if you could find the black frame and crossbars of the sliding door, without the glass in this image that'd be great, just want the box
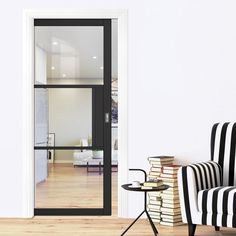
[34,19,112,215]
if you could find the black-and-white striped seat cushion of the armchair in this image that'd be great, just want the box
[198,186,236,215]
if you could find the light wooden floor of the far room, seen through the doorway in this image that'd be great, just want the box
[35,164,117,208]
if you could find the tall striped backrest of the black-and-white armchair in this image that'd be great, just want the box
[211,122,236,186]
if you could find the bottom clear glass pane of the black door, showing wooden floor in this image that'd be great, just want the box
[35,150,103,208]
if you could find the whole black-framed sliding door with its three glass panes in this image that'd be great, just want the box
[34,19,111,215]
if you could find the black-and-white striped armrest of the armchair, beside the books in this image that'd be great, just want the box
[178,161,222,224]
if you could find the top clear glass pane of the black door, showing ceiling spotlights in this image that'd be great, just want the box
[35,26,104,84]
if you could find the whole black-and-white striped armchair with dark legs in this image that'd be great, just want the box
[178,123,236,236]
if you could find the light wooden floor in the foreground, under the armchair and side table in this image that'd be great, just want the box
[0,217,236,236]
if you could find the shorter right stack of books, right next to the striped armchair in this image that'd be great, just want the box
[159,165,183,226]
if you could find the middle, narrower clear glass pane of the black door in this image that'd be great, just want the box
[35,88,92,146]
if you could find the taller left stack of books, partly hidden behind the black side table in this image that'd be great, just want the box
[147,156,174,223]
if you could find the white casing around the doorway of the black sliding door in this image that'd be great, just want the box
[22,9,128,218]
